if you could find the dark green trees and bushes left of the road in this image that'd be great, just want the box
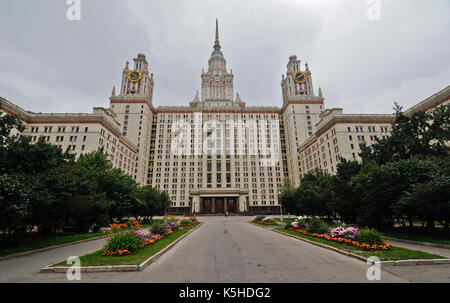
[0,104,170,246]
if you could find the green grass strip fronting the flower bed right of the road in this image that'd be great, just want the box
[276,227,445,261]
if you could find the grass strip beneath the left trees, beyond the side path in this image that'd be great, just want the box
[0,232,104,257]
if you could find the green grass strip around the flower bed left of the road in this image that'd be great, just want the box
[53,229,189,266]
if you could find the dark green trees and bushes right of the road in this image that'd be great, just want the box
[279,104,450,232]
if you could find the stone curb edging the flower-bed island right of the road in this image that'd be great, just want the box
[264,224,450,266]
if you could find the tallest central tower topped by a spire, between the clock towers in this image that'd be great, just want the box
[201,19,233,106]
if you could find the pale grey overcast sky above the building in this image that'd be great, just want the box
[0,0,450,113]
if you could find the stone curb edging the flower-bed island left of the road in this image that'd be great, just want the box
[39,222,205,273]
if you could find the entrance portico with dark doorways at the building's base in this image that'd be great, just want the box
[190,188,248,214]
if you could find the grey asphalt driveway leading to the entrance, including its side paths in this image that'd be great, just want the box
[0,217,450,283]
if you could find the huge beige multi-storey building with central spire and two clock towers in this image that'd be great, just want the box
[0,20,450,214]
